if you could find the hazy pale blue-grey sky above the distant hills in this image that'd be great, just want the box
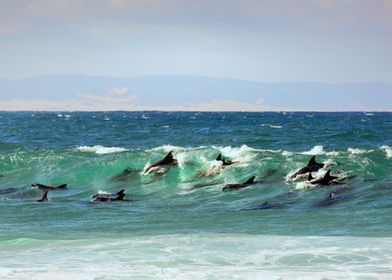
[0,0,392,83]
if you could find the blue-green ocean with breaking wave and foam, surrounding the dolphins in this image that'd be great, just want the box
[0,112,392,279]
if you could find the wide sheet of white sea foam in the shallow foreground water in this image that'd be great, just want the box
[0,234,392,280]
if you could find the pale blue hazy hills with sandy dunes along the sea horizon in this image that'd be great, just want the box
[0,75,392,111]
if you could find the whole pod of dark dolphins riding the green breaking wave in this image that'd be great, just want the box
[0,151,352,210]
